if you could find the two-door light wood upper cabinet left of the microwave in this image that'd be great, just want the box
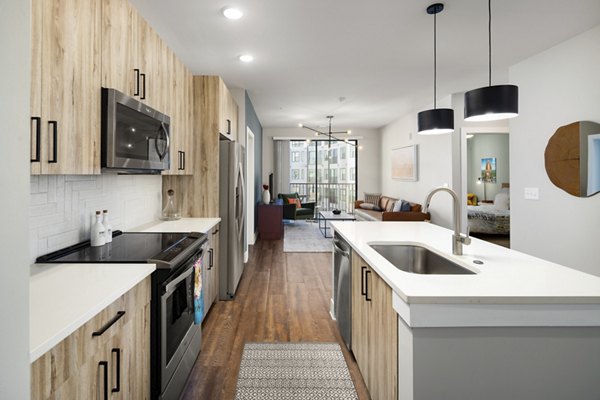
[31,0,101,174]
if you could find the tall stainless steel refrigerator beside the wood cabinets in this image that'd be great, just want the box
[219,140,246,300]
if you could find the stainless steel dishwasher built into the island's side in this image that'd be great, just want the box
[333,232,352,349]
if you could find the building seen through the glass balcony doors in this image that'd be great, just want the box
[290,140,357,212]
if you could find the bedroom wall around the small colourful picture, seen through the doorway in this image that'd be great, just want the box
[467,133,510,200]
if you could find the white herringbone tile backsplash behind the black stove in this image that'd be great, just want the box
[29,174,162,263]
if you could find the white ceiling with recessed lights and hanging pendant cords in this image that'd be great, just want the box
[132,0,600,130]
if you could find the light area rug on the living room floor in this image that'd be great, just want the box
[283,221,331,253]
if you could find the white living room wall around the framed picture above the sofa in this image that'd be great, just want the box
[380,98,452,228]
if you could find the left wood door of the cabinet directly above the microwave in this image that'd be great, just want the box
[102,0,137,98]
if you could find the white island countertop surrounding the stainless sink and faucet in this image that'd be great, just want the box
[332,222,600,306]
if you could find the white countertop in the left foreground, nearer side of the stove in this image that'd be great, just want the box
[29,264,156,362]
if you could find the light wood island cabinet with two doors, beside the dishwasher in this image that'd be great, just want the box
[352,253,398,400]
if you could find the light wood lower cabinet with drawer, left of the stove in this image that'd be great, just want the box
[31,277,151,400]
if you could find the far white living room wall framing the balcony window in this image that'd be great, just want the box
[262,127,381,199]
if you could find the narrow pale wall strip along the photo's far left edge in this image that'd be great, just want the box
[0,0,31,399]
